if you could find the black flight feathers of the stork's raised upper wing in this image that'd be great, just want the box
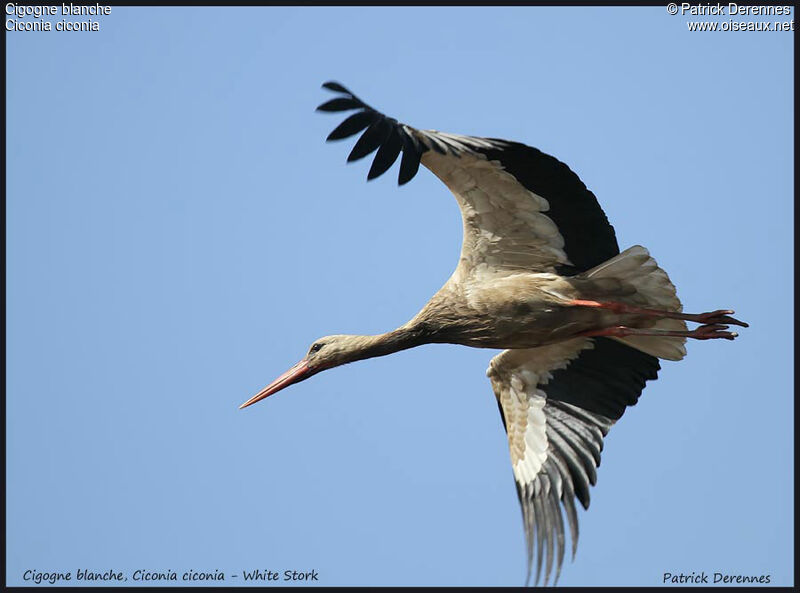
[317,82,619,273]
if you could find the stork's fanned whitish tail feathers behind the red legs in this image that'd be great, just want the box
[584,245,687,360]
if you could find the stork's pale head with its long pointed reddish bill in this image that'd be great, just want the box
[239,335,374,409]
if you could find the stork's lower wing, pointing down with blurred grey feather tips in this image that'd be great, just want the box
[486,338,659,584]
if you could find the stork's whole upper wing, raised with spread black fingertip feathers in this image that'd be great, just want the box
[317,82,619,274]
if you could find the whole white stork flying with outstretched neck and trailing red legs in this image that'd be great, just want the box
[241,82,747,584]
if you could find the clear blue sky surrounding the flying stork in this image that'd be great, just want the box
[6,7,794,585]
